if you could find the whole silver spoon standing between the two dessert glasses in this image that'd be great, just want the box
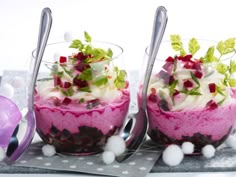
[116,6,167,162]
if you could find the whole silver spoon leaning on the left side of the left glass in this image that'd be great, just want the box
[5,8,52,164]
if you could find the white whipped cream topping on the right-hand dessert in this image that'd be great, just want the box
[148,60,232,111]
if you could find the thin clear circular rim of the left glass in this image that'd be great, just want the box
[31,40,124,66]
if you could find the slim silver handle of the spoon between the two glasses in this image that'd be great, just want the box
[142,6,168,110]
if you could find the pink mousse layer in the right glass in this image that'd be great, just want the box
[147,100,236,140]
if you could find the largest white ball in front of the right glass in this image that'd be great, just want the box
[162,144,184,166]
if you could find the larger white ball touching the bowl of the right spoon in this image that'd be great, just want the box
[105,135,126,156]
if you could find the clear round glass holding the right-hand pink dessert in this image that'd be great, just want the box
[138,40,236,152]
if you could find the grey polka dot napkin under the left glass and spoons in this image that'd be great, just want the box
[10,142,161,177]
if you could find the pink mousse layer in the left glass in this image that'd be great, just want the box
[34,90,130,135]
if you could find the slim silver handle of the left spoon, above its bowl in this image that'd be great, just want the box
[28,8,52,110]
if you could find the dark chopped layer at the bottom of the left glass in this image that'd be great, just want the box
[37,126,118,155]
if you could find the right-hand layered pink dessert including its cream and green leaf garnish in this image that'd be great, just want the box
[138,35,236,152]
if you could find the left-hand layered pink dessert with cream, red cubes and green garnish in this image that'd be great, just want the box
[34,32,130,155]
